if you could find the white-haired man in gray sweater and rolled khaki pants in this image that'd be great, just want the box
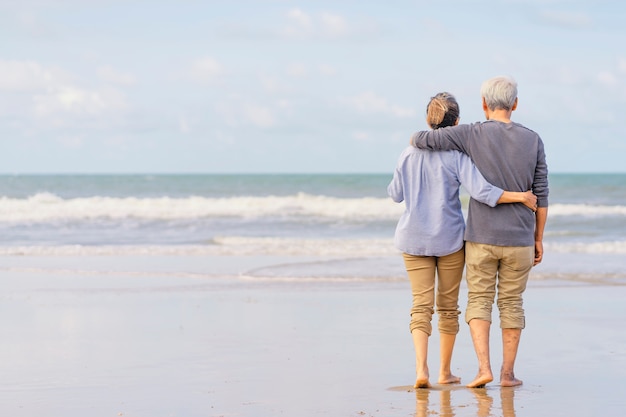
[411,77,548,387]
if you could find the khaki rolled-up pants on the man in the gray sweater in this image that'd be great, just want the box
[465,242,535,329]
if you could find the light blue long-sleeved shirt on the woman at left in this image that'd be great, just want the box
[387,146,503,256]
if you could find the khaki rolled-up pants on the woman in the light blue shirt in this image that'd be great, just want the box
[403,249,465,335]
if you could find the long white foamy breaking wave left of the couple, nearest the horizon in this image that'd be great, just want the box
[0,193,403,222]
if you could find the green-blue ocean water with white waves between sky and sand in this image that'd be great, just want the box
[0,174,626,283]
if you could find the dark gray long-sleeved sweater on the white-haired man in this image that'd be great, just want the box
[411,121,548,246]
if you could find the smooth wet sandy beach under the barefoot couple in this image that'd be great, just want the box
[0,252,626,417]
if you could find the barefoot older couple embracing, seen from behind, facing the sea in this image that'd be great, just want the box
[387,77,548,388]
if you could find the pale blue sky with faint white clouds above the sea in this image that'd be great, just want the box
[0,0,626,174]
